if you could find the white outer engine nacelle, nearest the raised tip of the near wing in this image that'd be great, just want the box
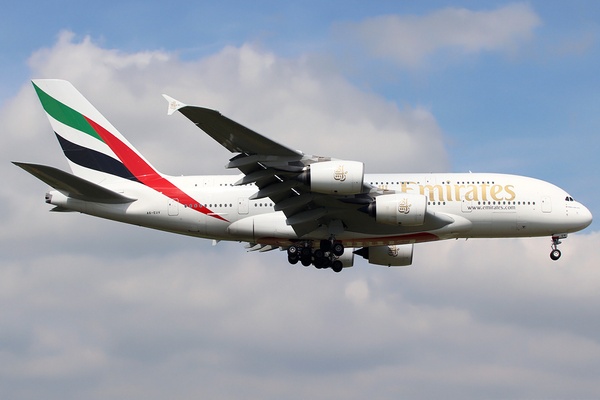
[308,160,365,195]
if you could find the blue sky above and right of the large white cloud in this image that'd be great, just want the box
[0,1,600,209]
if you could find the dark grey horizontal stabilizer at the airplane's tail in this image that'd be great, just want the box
[13,162,136,204]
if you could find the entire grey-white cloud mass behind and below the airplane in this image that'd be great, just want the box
[0,29,600,399]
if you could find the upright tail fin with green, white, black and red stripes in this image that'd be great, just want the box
[32,79,160,182]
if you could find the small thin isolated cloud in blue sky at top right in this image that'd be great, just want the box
[341,3,540,68]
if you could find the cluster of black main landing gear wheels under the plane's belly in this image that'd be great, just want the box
[287,239,344,272]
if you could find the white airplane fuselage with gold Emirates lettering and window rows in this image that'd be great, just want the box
[48,173,592,247]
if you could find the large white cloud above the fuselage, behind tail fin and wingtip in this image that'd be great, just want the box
[16,32,448,174]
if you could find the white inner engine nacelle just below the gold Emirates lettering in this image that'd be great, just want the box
[369,193,427,226]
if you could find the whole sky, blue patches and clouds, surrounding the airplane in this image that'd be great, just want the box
[0,1,600,399]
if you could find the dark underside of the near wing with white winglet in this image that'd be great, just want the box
[163,95,448,237]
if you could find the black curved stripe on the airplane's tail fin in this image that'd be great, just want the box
[54,132,139,182]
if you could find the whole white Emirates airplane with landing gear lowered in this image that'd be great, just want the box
[13,79,592,272]
